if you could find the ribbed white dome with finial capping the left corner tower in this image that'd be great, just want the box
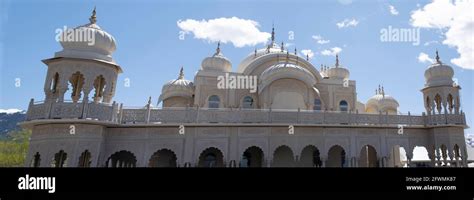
[55,9,116,62]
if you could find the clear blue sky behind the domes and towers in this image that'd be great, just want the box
[0,0,474,136]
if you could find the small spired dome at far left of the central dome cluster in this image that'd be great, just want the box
[159,68,194,102]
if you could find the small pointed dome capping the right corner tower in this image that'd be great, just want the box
[425,51,454,87]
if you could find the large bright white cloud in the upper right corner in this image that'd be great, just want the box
[410,0,474,69]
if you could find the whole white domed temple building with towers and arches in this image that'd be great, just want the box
[22,10,468,167]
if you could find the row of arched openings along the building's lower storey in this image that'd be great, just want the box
[30,144,463,168]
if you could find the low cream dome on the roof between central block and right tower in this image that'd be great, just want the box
[365,88,399,114]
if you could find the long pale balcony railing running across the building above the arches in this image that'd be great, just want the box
[27,100,466,126]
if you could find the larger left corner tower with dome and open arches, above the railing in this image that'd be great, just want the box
[43,8,122,103]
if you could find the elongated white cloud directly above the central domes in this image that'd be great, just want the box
[177,17,271,47]
